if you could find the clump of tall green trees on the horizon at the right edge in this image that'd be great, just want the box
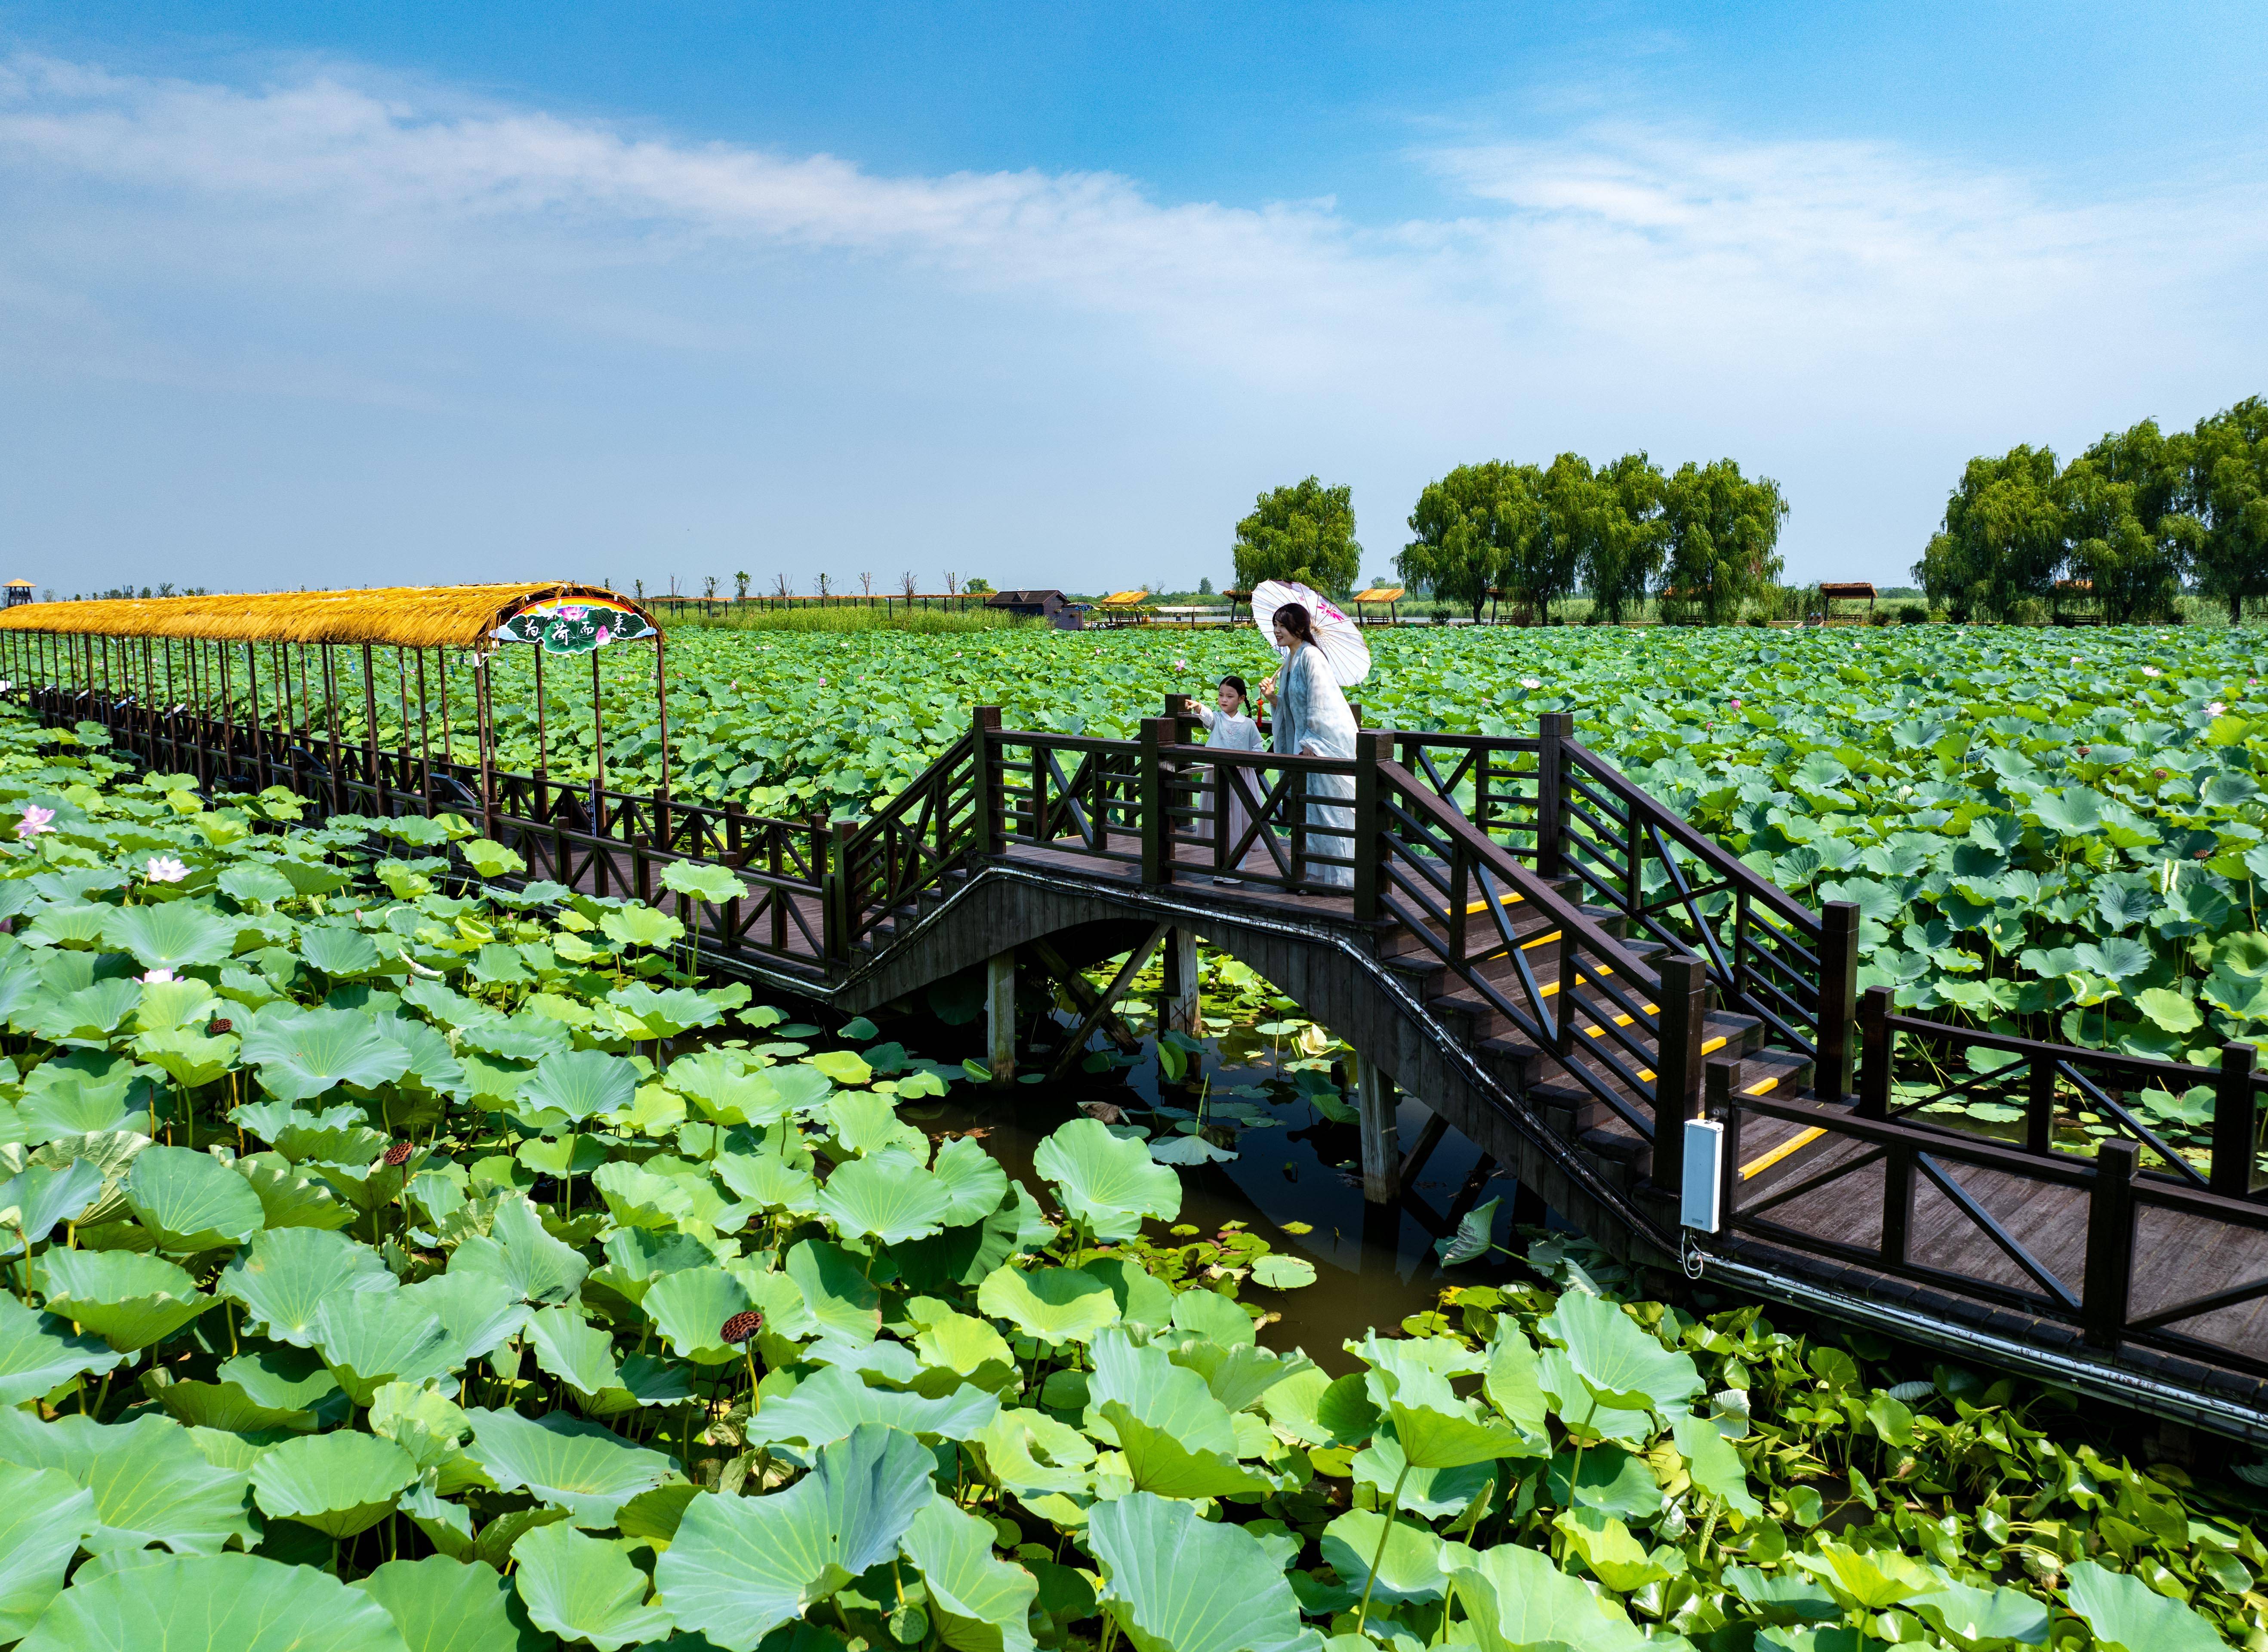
[1914,397,2268,624]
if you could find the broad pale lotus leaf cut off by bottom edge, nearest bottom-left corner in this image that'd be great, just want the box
[23,1554,408,1652]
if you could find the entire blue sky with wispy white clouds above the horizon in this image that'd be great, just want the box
[0,0,2268,590]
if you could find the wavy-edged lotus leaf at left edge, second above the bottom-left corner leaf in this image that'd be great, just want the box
[0,1412,254,1554]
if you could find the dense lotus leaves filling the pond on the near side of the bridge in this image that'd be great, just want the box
[0,721,2268,1652]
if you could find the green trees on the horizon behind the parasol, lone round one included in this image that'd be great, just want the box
[1234,454,1787,624]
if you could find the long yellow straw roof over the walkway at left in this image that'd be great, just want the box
[0,583,651,649]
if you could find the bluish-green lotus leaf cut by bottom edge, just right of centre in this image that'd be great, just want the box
[1086,1489,1322,1652]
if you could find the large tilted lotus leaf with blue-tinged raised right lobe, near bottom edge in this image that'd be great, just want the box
[653,1423,937,1652]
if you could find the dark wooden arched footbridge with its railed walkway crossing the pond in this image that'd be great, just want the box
[14,599,2268,1441]
